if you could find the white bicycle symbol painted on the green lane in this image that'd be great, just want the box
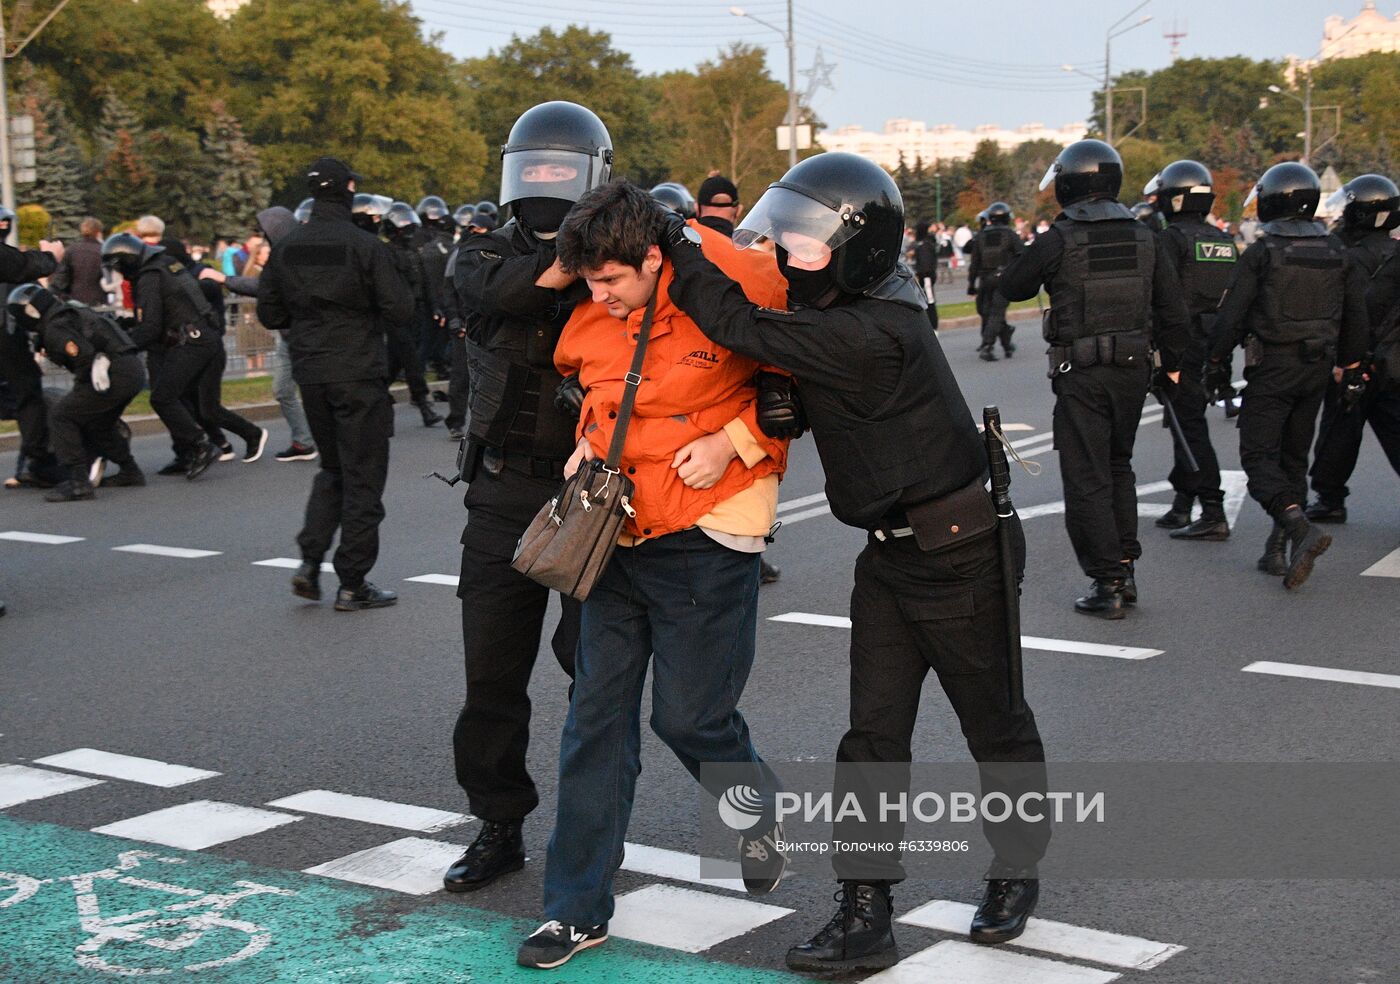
[0,850,297,977]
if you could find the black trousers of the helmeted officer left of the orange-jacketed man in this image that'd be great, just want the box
[452,459,581,822]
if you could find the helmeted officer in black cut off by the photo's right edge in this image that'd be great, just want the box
[1305,174,1400,522]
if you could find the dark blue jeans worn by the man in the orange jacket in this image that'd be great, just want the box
[545,529,773,925]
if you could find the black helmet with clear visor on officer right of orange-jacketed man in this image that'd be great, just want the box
[734,151,904,294]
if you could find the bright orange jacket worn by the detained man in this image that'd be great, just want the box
[554,223,788,537]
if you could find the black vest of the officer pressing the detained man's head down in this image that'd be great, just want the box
[802,298,987,529]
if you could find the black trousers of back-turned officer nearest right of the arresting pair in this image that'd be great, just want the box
[1051,365,1148,578]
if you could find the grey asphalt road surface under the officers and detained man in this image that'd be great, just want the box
[0,323,1400,984]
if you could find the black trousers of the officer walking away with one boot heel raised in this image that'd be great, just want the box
[1239,354,1331,521]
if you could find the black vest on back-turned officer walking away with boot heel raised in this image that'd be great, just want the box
[1254,220,1347,346]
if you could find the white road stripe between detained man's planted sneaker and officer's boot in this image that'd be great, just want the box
[608,885,794,953]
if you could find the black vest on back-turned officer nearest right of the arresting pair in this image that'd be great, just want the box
[1046,200,1156,344]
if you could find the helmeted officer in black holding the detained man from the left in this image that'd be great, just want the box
[444,102,613,892]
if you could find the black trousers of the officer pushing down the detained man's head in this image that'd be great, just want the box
[833,519,1050,882]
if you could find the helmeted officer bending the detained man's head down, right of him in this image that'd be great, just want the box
[665,153,1049,971]
